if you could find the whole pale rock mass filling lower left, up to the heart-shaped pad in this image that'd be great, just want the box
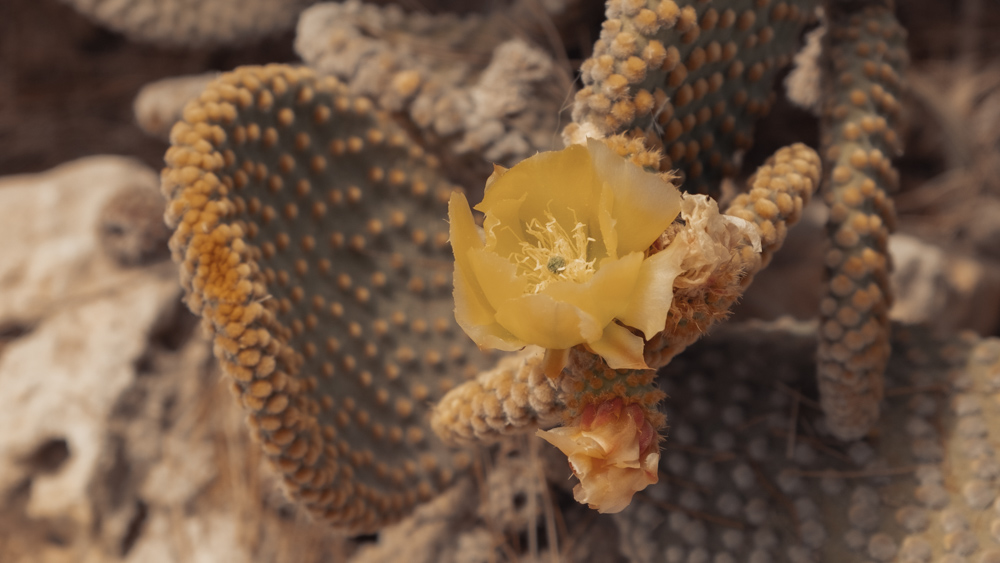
[0,157,345,563]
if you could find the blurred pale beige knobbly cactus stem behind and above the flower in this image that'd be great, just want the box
[295,0,572,177]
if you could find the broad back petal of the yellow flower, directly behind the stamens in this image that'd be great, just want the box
[476,145,601,238]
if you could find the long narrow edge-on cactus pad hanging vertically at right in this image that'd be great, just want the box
[818,3,907,440]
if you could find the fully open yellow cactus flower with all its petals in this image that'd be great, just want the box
[448,140,685,369]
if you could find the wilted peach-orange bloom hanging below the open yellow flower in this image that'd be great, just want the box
[538,398,660,513]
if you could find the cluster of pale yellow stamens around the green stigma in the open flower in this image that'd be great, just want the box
[514,211,596,293]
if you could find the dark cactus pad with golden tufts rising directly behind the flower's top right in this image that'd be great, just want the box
[563,0,817,195]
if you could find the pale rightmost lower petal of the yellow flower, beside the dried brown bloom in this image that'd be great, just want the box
[618,240,686,339]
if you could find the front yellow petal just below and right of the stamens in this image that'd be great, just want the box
[542,252,642,326]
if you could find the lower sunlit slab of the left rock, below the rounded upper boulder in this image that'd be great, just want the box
[0,278,179,523]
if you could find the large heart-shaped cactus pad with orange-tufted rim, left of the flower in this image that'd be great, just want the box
[163,65,492,532]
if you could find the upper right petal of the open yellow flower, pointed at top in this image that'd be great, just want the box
[587,139,681,254]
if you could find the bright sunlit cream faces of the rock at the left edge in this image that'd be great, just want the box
[0,157,180,524]
